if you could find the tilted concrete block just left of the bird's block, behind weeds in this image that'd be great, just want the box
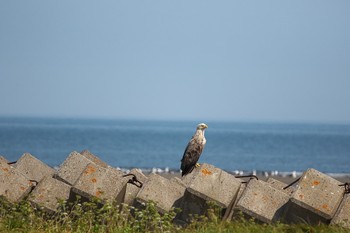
[136,174,186,213]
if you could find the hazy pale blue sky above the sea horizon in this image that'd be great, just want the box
[0,0,350,123]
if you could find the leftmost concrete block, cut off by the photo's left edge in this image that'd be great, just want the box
[0,161,33,202]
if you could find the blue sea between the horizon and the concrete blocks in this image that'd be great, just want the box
[0,117,350,173]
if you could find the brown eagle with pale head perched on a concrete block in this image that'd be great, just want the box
[181,123,208,176]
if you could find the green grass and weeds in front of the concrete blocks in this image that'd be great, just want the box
[0,199,350,233]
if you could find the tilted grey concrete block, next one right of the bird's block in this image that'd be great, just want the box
[237,179,289,223]
